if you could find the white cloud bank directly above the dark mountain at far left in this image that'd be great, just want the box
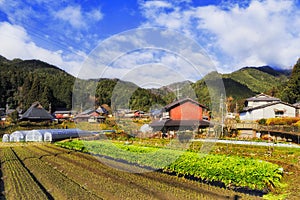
[0,22,86,76]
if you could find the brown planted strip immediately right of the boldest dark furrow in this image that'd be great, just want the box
[14,147,99,199]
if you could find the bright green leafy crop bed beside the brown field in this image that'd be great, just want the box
[58,140,283,191]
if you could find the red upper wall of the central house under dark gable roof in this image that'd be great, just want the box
[169,102,202,120]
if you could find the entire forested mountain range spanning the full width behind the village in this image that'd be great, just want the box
[0,56,300,114]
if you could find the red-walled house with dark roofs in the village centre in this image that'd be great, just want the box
[150,98,210,133]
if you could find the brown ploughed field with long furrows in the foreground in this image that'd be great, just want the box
[0,144,259,199]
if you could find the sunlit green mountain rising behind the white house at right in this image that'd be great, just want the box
[162,66,294,112]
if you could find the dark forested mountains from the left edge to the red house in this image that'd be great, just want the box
[0,56,165,112]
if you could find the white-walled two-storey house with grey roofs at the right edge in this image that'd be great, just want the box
[240,94,298,121]
